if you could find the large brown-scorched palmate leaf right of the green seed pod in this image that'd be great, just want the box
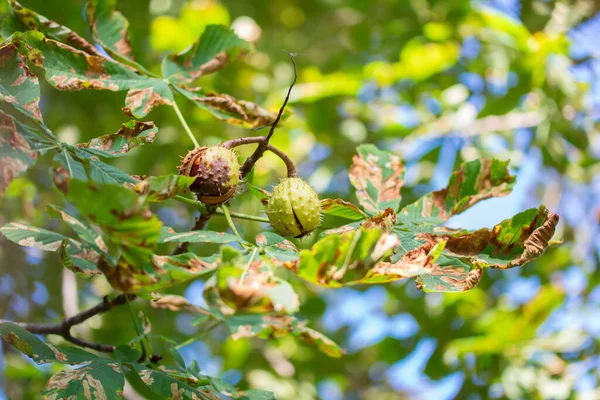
[284,145,558,292]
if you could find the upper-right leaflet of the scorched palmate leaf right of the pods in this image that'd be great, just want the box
[398,159,515,225]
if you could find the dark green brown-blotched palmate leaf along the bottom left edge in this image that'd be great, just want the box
[0,323,273,400]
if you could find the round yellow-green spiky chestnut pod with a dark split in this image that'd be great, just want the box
[267,178,321,238]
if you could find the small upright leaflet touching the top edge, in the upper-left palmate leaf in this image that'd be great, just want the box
[87,0,131,58]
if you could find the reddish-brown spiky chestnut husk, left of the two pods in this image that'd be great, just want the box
[179,146,240,204]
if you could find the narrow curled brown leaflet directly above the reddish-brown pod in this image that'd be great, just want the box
[175,86,275,128]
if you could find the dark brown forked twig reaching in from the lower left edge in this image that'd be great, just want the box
[0,294,135,353]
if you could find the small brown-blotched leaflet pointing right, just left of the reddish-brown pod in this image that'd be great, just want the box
[77,120,158,157]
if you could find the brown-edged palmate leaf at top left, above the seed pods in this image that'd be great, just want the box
[0,7,275,127]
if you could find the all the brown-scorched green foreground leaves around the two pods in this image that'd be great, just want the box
[0,0,558,399]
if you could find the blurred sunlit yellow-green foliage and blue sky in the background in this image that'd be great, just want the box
[0,0,600,400]
